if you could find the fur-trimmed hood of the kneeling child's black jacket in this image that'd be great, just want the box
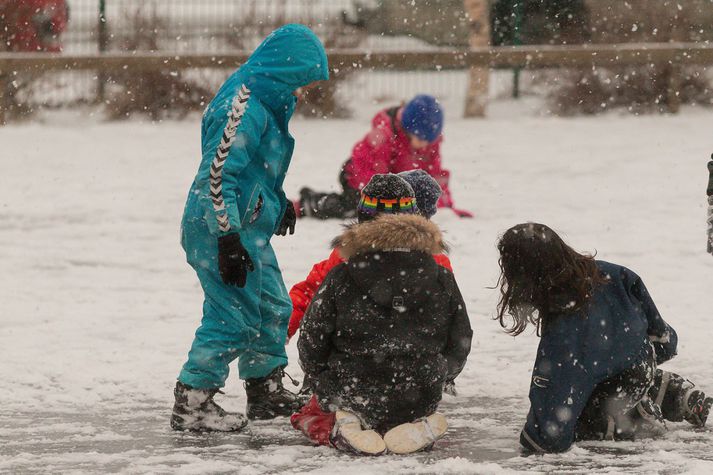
[334,214,446,313]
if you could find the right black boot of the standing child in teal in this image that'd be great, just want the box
[245,367,301,420]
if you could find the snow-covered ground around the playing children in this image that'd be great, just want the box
[0,101,713,474]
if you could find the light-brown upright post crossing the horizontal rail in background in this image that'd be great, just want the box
[463,0,490,117]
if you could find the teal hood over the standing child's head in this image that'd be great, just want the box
[240,24,329,119]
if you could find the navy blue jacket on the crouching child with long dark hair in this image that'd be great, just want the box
[520,261,678,452]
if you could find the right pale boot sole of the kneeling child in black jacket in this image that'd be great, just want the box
[384,412,448,454]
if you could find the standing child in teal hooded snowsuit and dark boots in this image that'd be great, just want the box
[171,25,328,430]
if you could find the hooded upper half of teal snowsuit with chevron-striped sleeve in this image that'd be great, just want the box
[183,24,329,252]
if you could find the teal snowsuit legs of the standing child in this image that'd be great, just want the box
[178,210,292,389]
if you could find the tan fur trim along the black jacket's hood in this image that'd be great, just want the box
[332,214,448,260]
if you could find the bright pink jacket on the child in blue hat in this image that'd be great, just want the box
[344,108,453,208]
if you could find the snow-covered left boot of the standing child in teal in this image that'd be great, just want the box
[171,381,248,432]
